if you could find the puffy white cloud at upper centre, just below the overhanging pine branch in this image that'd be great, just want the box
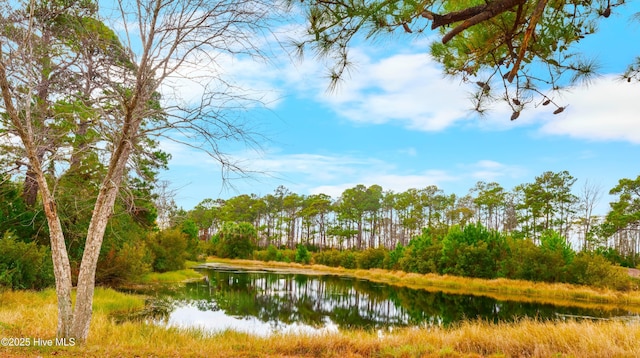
[310,49,476,131]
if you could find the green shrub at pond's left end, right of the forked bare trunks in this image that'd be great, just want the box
[147,229,188,272]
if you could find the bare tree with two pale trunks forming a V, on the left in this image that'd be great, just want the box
[0,0,274,341]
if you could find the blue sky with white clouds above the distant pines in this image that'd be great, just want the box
[161,3,640,214]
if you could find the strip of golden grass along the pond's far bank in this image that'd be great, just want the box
[209,258,640,312]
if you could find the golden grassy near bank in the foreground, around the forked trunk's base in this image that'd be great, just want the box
[0,289,640,357]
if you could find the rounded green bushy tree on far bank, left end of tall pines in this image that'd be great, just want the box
[216,221,257,259]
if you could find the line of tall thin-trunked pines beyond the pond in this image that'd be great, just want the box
[181,171,640,267]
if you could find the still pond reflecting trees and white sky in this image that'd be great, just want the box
[129,267,638,335]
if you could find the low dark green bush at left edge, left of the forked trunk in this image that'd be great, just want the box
[0,232,54,289]
